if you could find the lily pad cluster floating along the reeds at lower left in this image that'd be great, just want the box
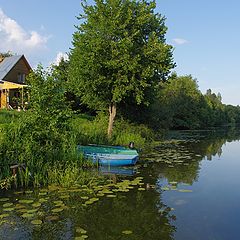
[0,177,145,229]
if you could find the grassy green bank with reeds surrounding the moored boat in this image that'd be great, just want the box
[0,111,153,188]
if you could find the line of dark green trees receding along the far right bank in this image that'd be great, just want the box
[115,73,240,129]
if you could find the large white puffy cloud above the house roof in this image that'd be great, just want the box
[0,8,49,54]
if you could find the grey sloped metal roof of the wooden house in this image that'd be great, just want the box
[0,55,31,80]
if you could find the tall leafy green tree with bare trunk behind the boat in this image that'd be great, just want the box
[69,0,175,137]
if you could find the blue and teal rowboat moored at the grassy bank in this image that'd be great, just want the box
[78,145,139,166]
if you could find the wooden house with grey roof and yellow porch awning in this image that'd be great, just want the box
[0,55,31,109]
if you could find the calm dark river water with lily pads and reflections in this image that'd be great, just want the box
[0,130,240,240]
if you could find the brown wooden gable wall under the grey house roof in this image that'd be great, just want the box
[3,58,30,83]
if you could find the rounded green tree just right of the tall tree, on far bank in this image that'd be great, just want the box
[154,74,206,129]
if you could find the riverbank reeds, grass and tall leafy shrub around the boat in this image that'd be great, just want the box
[0,66,153,188]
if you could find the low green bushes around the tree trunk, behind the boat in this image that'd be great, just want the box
[71,113,154,148]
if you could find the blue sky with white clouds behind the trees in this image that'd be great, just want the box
[0,0,240,105]
